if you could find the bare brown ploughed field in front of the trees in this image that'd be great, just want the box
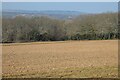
[2,40,118,78]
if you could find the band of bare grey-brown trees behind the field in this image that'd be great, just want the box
[2,13,119,43]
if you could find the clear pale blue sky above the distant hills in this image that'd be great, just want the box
[2,2,118,13]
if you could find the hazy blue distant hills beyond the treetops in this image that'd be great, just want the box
[2,10,85,19]
